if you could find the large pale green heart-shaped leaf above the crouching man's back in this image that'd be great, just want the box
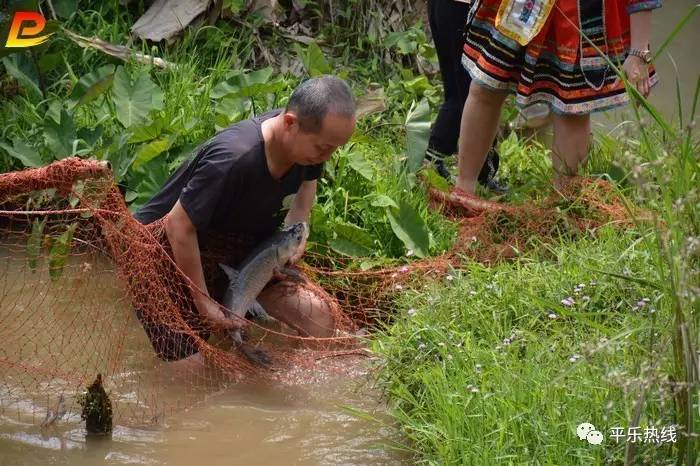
[112,66,163,128]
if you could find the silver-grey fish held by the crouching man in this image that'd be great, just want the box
[219,223,309,366]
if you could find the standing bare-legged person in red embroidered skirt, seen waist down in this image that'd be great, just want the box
[452,0,661,198]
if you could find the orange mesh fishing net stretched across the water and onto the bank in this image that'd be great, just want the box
[0,158,628,424]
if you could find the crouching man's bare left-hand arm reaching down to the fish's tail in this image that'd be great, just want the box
[165,201,243,329]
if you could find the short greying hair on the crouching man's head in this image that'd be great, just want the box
[285,75,355,133]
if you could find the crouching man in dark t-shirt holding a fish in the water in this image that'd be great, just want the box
[135,76,355,368]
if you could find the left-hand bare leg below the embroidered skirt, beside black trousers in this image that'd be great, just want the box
[457,81,508,194]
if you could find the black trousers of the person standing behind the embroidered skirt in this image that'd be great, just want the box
[428,0,498,183]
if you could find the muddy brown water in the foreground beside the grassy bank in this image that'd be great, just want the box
[0,240,406,466]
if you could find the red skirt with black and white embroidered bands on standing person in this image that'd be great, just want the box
[462,0,660,114]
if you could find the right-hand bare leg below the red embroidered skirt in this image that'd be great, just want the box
[552,115,591,189]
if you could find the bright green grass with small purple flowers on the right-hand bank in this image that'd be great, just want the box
[373,228,674,465]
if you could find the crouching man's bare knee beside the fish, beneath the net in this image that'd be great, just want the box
[258,282,336,337]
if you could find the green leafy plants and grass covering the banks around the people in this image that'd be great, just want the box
[0,0,700,465]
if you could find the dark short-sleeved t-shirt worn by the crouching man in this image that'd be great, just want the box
[134,110,322,240]
